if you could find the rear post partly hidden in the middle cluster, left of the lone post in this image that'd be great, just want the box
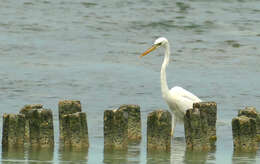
[119,104,142,142]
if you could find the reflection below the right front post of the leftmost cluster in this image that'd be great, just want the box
[28,146,54,163]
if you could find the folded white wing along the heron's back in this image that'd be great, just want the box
[170,86,201,102]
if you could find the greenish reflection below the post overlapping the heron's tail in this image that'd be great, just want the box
[184,150,208,164]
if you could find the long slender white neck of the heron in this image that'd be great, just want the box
[161,44,170,98]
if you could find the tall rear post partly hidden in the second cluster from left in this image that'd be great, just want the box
[59,100,82,142]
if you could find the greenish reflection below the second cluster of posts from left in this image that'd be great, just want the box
[59,146,88,163]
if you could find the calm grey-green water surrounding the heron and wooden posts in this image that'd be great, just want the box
[0,0,260,164]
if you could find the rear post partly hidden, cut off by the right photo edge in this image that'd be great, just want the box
[238,107,260,141]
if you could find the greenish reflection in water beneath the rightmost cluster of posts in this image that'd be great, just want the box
[232,151,257,164]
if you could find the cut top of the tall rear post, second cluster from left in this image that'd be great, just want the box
[59,100,82,118]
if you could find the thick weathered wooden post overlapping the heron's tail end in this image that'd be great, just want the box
[184,102,217,151]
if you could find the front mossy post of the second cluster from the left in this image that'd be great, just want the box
[61,112,89,149]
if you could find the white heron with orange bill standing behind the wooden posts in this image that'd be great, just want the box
[140,37,201,135]
